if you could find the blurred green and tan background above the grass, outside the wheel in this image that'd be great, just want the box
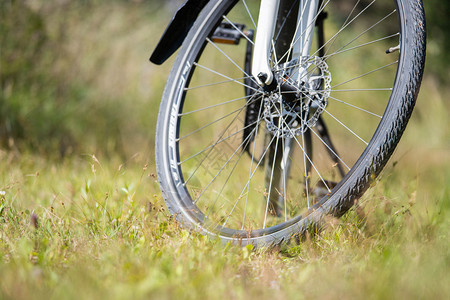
[0,0,450,157]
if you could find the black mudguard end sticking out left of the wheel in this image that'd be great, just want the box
[150,0,209,65]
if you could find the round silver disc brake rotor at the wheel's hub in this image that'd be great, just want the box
[263,56,331,138]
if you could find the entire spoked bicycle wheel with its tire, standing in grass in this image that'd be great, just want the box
[156,0,425,244]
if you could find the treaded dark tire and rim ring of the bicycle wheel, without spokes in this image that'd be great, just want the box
[156,0,426,245]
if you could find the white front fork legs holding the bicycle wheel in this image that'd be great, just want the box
[252,0,320,86]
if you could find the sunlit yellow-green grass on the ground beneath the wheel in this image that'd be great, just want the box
[0,145,450,299]
